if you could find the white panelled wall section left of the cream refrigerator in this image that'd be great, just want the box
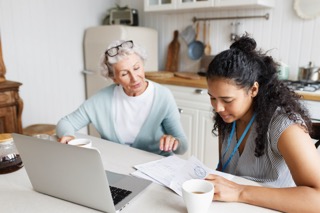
[0,0,115,131]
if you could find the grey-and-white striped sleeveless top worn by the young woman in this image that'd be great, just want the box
[221,108,302,187]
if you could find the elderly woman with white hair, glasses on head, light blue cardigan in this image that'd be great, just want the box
[56,40,187,156]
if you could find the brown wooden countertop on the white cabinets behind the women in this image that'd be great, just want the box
[148,74,320,101]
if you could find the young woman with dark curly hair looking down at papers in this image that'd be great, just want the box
[207,35,320,212]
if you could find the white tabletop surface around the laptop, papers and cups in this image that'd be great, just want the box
[0,134,275,213]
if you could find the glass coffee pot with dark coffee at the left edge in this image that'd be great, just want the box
[0,133,23,174]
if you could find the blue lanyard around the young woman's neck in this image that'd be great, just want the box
[221,114,256,171]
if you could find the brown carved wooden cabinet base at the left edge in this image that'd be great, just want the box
[0,80,23,134]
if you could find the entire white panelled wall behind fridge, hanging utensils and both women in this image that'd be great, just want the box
[0,0,320,131]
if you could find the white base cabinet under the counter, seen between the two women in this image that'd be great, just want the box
[164,85,219,169]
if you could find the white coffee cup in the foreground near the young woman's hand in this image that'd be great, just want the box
[182,179,214,213]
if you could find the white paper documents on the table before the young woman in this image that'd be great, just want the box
[131,155,233,196]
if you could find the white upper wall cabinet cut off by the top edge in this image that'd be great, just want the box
[144,0,275,12]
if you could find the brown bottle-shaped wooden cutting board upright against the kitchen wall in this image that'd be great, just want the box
[166,30,180,72]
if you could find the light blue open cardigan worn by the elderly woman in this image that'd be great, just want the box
[56,82,188,156]
